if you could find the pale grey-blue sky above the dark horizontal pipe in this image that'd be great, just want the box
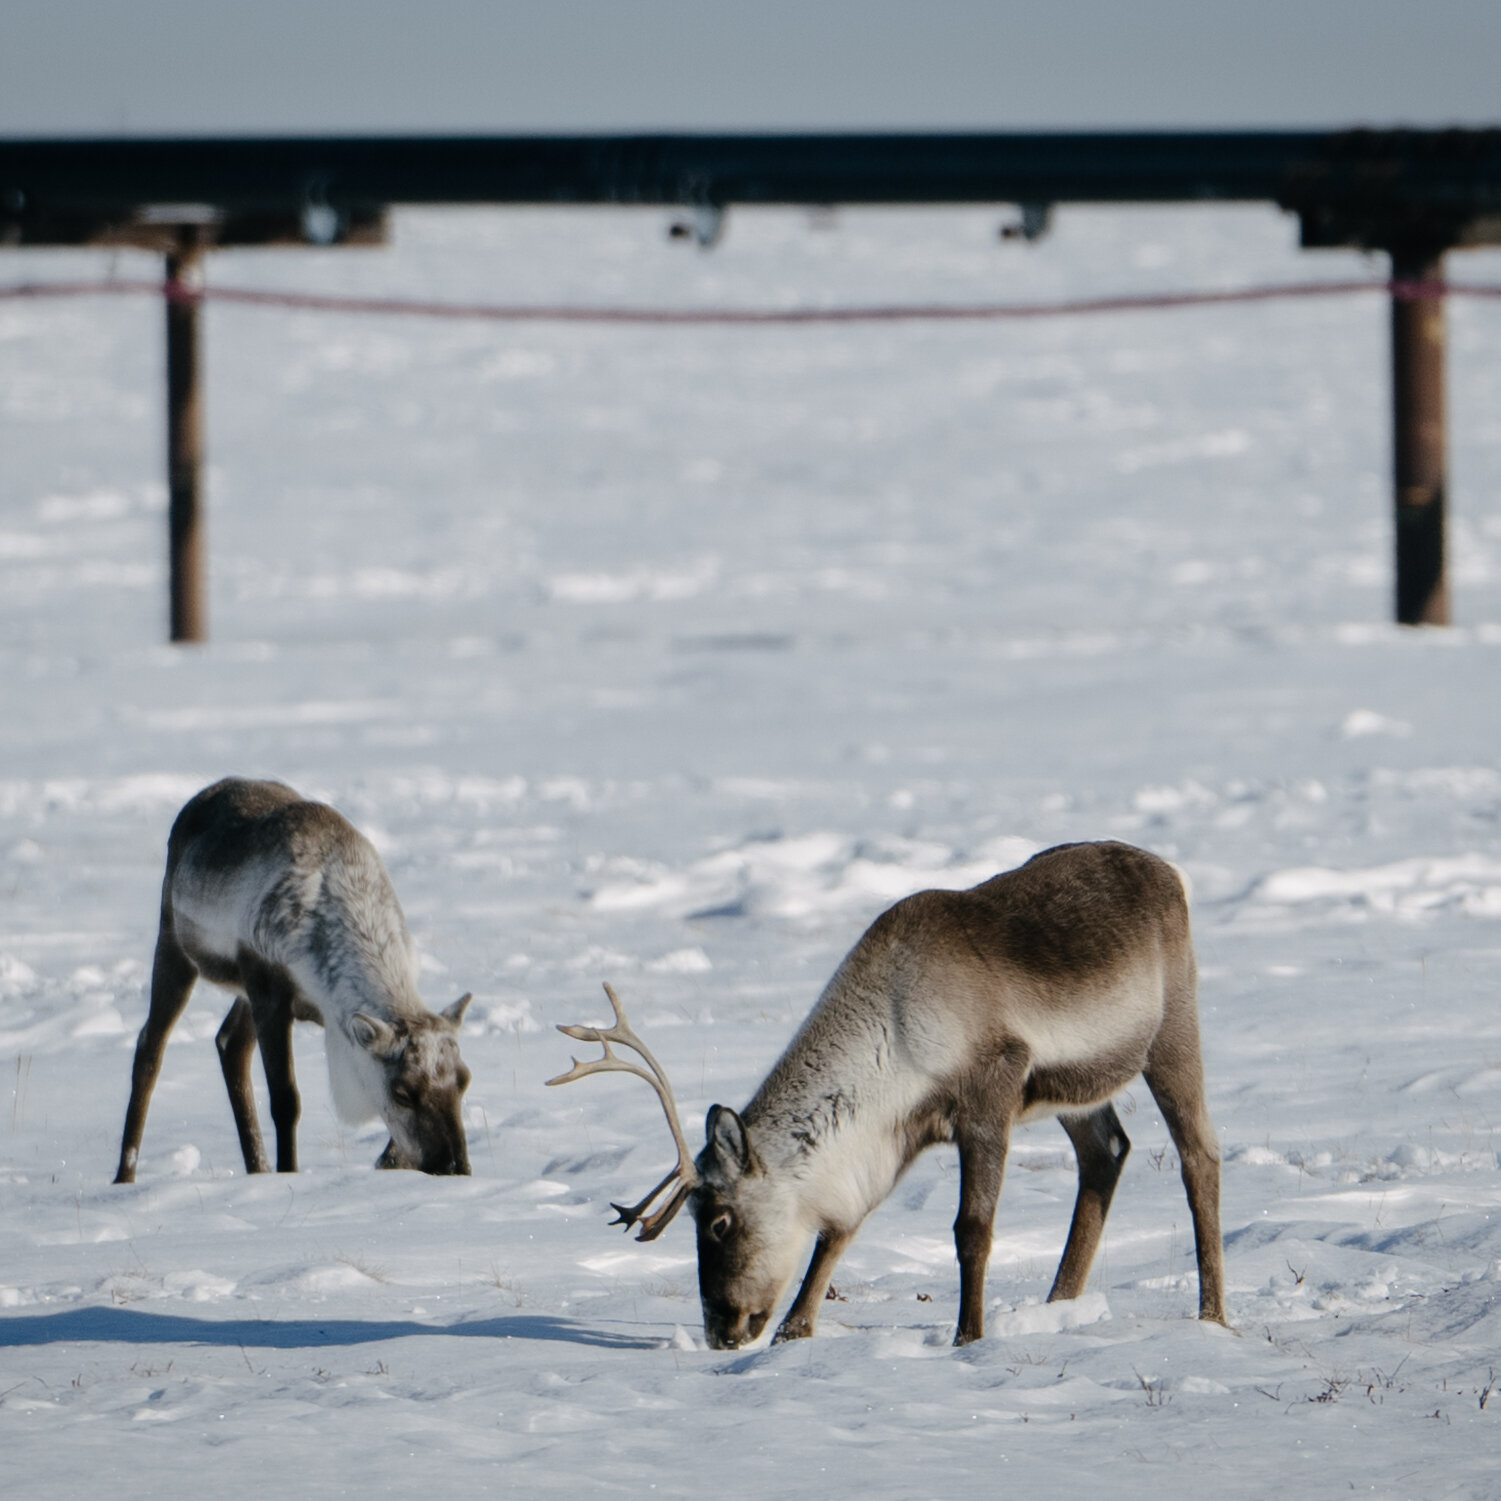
[0,0,1501,137]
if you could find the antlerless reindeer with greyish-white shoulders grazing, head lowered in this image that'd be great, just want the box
[114,778,470,1183]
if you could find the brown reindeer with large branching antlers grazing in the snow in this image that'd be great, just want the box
[548,842,1225,1349]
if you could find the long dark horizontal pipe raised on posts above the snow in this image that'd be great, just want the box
[0,131,1501,222]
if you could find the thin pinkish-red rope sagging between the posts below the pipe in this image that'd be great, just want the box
[0,279,1501,326]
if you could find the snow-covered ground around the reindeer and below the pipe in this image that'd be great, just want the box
[0,209,1501,1501]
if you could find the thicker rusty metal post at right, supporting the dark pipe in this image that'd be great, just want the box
[1391,248,1448,626]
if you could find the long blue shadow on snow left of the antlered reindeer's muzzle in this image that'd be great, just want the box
[0,1307,662,1349]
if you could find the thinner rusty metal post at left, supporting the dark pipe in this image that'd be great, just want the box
[165,237,209,641]
